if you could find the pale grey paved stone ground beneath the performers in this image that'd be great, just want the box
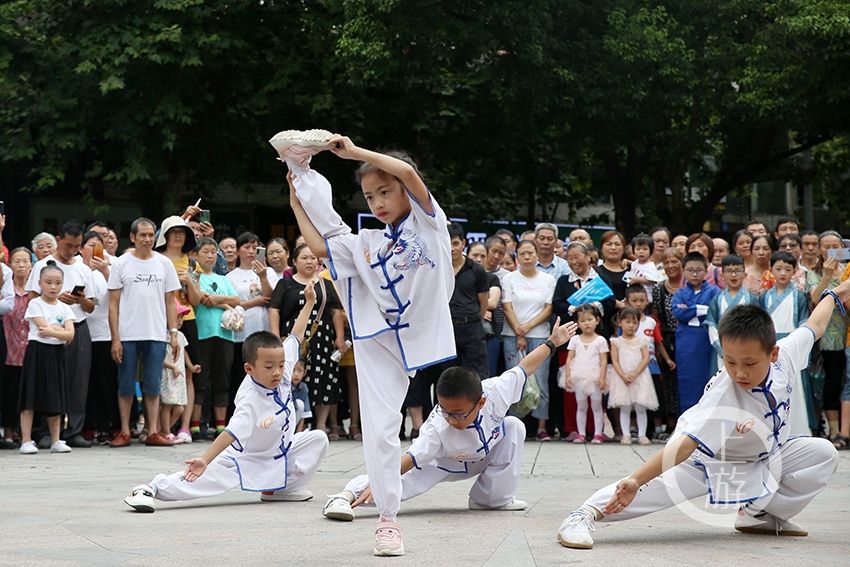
[0,441,850,567]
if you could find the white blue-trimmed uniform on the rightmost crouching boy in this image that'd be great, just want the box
[585,327,838,522]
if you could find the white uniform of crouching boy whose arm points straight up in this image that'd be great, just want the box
[151,336,328,501]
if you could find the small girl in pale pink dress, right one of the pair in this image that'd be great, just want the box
[608,307,658,445]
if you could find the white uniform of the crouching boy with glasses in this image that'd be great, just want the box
[345,368,527,508]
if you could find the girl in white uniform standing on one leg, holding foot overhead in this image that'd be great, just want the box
[278,135,455,556]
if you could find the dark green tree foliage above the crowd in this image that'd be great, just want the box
[0,0,850,232]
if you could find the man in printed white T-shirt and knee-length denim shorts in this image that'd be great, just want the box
[107,218,180,447]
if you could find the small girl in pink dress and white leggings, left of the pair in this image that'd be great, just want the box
[561,303,608,444]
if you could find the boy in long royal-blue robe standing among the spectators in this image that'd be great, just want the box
[671,252,720,415]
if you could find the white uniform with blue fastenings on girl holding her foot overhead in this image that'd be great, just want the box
[287,161,456,519]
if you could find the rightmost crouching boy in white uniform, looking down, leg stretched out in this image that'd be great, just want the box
[558,280,850,549]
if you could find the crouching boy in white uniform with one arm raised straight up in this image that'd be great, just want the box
[124,285,328,512]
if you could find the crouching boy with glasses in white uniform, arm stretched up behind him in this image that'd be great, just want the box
[322,319,577,522]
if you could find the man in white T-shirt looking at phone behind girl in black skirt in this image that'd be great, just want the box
[25,221,94,447]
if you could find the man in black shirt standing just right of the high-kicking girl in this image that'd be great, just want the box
[449,223,490,380]
